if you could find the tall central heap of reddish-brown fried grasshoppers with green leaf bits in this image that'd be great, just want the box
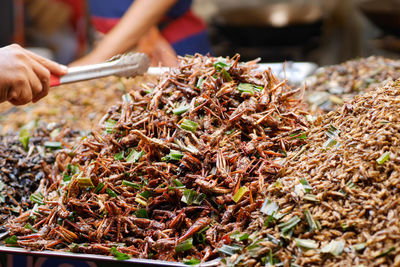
[8,55,307,261]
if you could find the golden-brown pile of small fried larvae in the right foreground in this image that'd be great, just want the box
[222,81,400,266]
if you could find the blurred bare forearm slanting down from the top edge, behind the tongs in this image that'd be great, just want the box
[93,0,176,60]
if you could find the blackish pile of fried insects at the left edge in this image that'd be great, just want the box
[0,124,78,226]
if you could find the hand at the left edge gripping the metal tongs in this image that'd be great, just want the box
[0,44,68,105]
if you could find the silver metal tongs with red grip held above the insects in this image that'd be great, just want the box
[50,53,150,86]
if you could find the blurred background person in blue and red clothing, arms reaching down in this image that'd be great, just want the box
[72,0,211,66]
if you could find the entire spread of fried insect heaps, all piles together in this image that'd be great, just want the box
[0,55,400,266]
